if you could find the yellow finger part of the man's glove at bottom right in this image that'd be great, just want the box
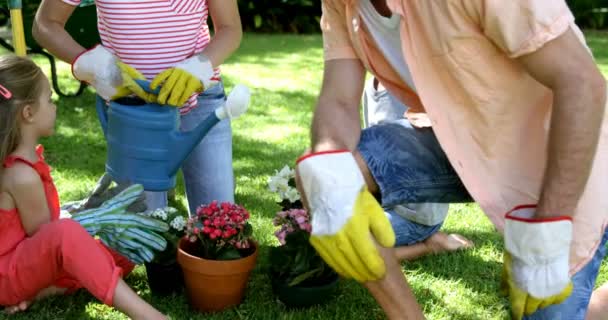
[501,252,572,320]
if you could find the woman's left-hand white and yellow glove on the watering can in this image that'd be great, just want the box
[72,45,155,102]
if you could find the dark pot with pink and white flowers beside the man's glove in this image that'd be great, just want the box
[269,167,338,307]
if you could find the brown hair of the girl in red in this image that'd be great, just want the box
[0,54,47,182]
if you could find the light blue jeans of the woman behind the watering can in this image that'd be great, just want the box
[146,83,234,215]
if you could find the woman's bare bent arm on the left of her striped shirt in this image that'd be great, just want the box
[32,0,85,63]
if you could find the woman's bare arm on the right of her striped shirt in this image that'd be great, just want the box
[203,0,243,67]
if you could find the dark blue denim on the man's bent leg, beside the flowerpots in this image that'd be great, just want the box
[357,119,471,246]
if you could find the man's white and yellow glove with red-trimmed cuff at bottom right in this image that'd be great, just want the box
[502,206,572,320]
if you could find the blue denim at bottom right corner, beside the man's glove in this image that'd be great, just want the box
[524,230,608,320]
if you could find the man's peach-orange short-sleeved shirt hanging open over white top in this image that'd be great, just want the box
[321,0,608,273]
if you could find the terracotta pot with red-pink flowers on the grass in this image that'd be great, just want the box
[177,201,258,312]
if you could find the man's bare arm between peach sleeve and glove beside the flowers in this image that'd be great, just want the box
[311,59,365,152]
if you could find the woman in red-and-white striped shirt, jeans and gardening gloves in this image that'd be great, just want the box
[33,0,242,218]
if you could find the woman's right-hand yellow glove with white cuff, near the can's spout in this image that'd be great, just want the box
[150,54,219,107]
